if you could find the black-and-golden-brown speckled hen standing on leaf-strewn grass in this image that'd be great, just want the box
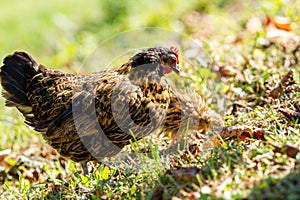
[0,47,209,173]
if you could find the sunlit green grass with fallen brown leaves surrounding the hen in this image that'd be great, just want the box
[0,0,300,199]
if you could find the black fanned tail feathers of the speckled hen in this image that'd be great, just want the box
[0,52,38,108]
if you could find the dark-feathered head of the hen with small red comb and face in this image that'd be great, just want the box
[130,47,180,75]
